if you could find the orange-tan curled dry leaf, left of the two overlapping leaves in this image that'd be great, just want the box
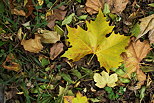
[21,35,43,53]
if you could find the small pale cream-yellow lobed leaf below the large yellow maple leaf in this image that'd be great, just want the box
[94,71,118,88]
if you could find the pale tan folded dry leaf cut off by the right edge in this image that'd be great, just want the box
[137,14,154,43]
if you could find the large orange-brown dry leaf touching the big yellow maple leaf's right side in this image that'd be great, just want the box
[122,38,151,89]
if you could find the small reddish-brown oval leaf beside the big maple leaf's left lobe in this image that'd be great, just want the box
[50,43,64,60]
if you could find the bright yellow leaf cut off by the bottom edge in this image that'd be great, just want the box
[72,92,88,103]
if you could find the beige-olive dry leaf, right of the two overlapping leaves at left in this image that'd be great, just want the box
[38,29,60,43]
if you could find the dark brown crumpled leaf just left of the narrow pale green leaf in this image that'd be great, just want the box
[46,6,67,29]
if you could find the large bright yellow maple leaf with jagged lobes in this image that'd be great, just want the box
[62,11,129,71]
